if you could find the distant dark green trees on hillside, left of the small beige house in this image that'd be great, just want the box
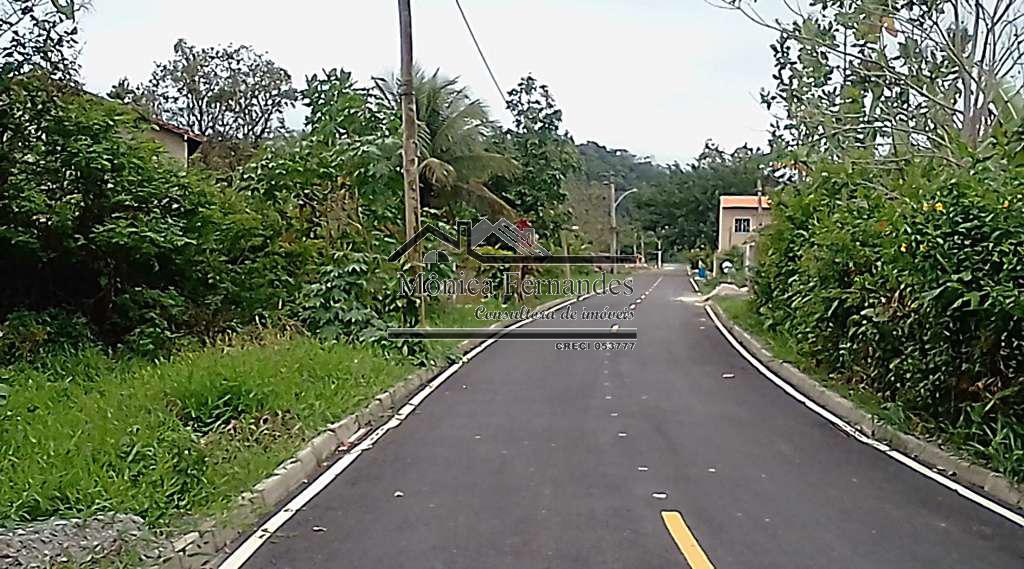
[636,141,766,251]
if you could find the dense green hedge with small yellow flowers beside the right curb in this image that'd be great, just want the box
[755,144,1024,477]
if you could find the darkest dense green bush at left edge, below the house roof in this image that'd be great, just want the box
[0,76,292,350]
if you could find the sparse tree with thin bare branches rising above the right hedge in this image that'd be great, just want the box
[726,0,1024,160]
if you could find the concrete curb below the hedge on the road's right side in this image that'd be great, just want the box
[709,303,1024,509]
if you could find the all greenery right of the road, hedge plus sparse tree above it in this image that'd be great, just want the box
[730,0,1024,479]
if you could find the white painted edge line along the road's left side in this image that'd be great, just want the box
[219,293,594,569]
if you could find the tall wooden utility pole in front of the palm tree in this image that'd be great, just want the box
[398,0,427,326]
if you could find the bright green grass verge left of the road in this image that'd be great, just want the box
[0,284,593,527]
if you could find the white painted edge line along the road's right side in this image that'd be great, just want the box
[694,302,1024,527]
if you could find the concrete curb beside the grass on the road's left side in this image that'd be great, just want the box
[150,297,571,569]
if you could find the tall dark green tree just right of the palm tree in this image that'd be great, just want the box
[498,76,581,238]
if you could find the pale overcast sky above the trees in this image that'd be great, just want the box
[81,0,773,163]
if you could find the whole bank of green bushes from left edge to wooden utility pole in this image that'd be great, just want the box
[0,72,415,356]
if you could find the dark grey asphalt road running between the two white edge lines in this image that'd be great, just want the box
[232,272,1024,569]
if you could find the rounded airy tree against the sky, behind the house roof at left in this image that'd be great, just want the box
[137,40,298,144]
